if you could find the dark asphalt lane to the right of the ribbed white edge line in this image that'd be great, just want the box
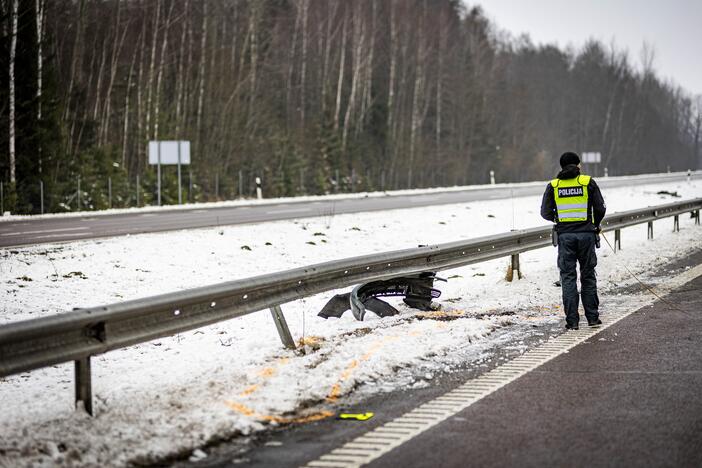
[368,276,702,468]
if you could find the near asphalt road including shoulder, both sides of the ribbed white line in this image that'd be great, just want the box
[180,250,702,468]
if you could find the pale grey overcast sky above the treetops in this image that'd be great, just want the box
[478,0,702,94]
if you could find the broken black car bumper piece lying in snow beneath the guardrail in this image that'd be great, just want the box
[318,271,446,320]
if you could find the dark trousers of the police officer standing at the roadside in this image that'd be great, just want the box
[558,232,600,325]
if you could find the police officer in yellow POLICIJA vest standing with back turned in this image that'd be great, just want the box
[541,152,606,330]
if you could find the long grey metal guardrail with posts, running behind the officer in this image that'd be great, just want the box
[0,198,702,414]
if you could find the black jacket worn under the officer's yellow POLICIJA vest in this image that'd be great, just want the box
[541,165,607,233]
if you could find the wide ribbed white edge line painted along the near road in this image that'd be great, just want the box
[304,265,702,468]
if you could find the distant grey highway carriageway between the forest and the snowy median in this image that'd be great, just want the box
[0,172,702,248]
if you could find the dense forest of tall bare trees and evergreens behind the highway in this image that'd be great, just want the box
[0,0,702,213]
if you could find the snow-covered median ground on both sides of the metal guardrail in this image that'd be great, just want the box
[0,181,702,466]
